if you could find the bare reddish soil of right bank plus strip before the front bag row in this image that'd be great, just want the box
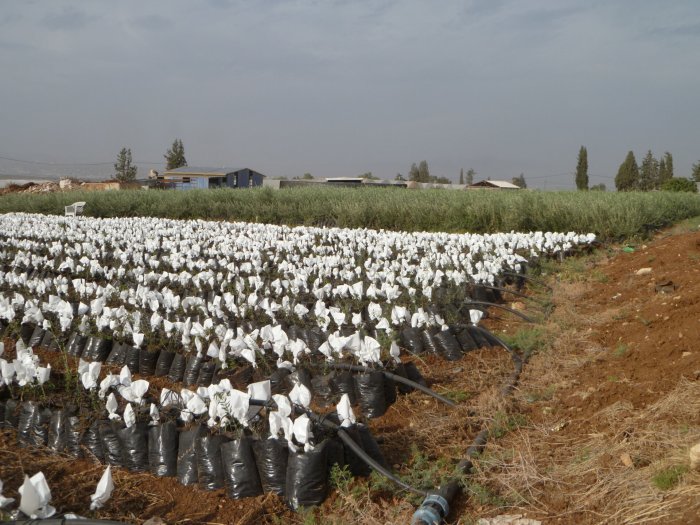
[0,223,700,524]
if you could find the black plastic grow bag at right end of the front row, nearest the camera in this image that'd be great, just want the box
[287,441,328,509]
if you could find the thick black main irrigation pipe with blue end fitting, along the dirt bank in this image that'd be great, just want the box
[411,326,525,525]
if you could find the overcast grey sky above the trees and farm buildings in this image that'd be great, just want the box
[0,0,700,189]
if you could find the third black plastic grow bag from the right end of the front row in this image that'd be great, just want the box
[221,435,262,499]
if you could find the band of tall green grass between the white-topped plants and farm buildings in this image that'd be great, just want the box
[0,187,700,239]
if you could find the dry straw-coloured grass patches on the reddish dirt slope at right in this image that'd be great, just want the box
[464,276,700,524]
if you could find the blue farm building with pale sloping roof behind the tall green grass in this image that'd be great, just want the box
[157,166,265,190]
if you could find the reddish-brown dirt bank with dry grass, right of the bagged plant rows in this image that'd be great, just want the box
[470,226,700,524]
